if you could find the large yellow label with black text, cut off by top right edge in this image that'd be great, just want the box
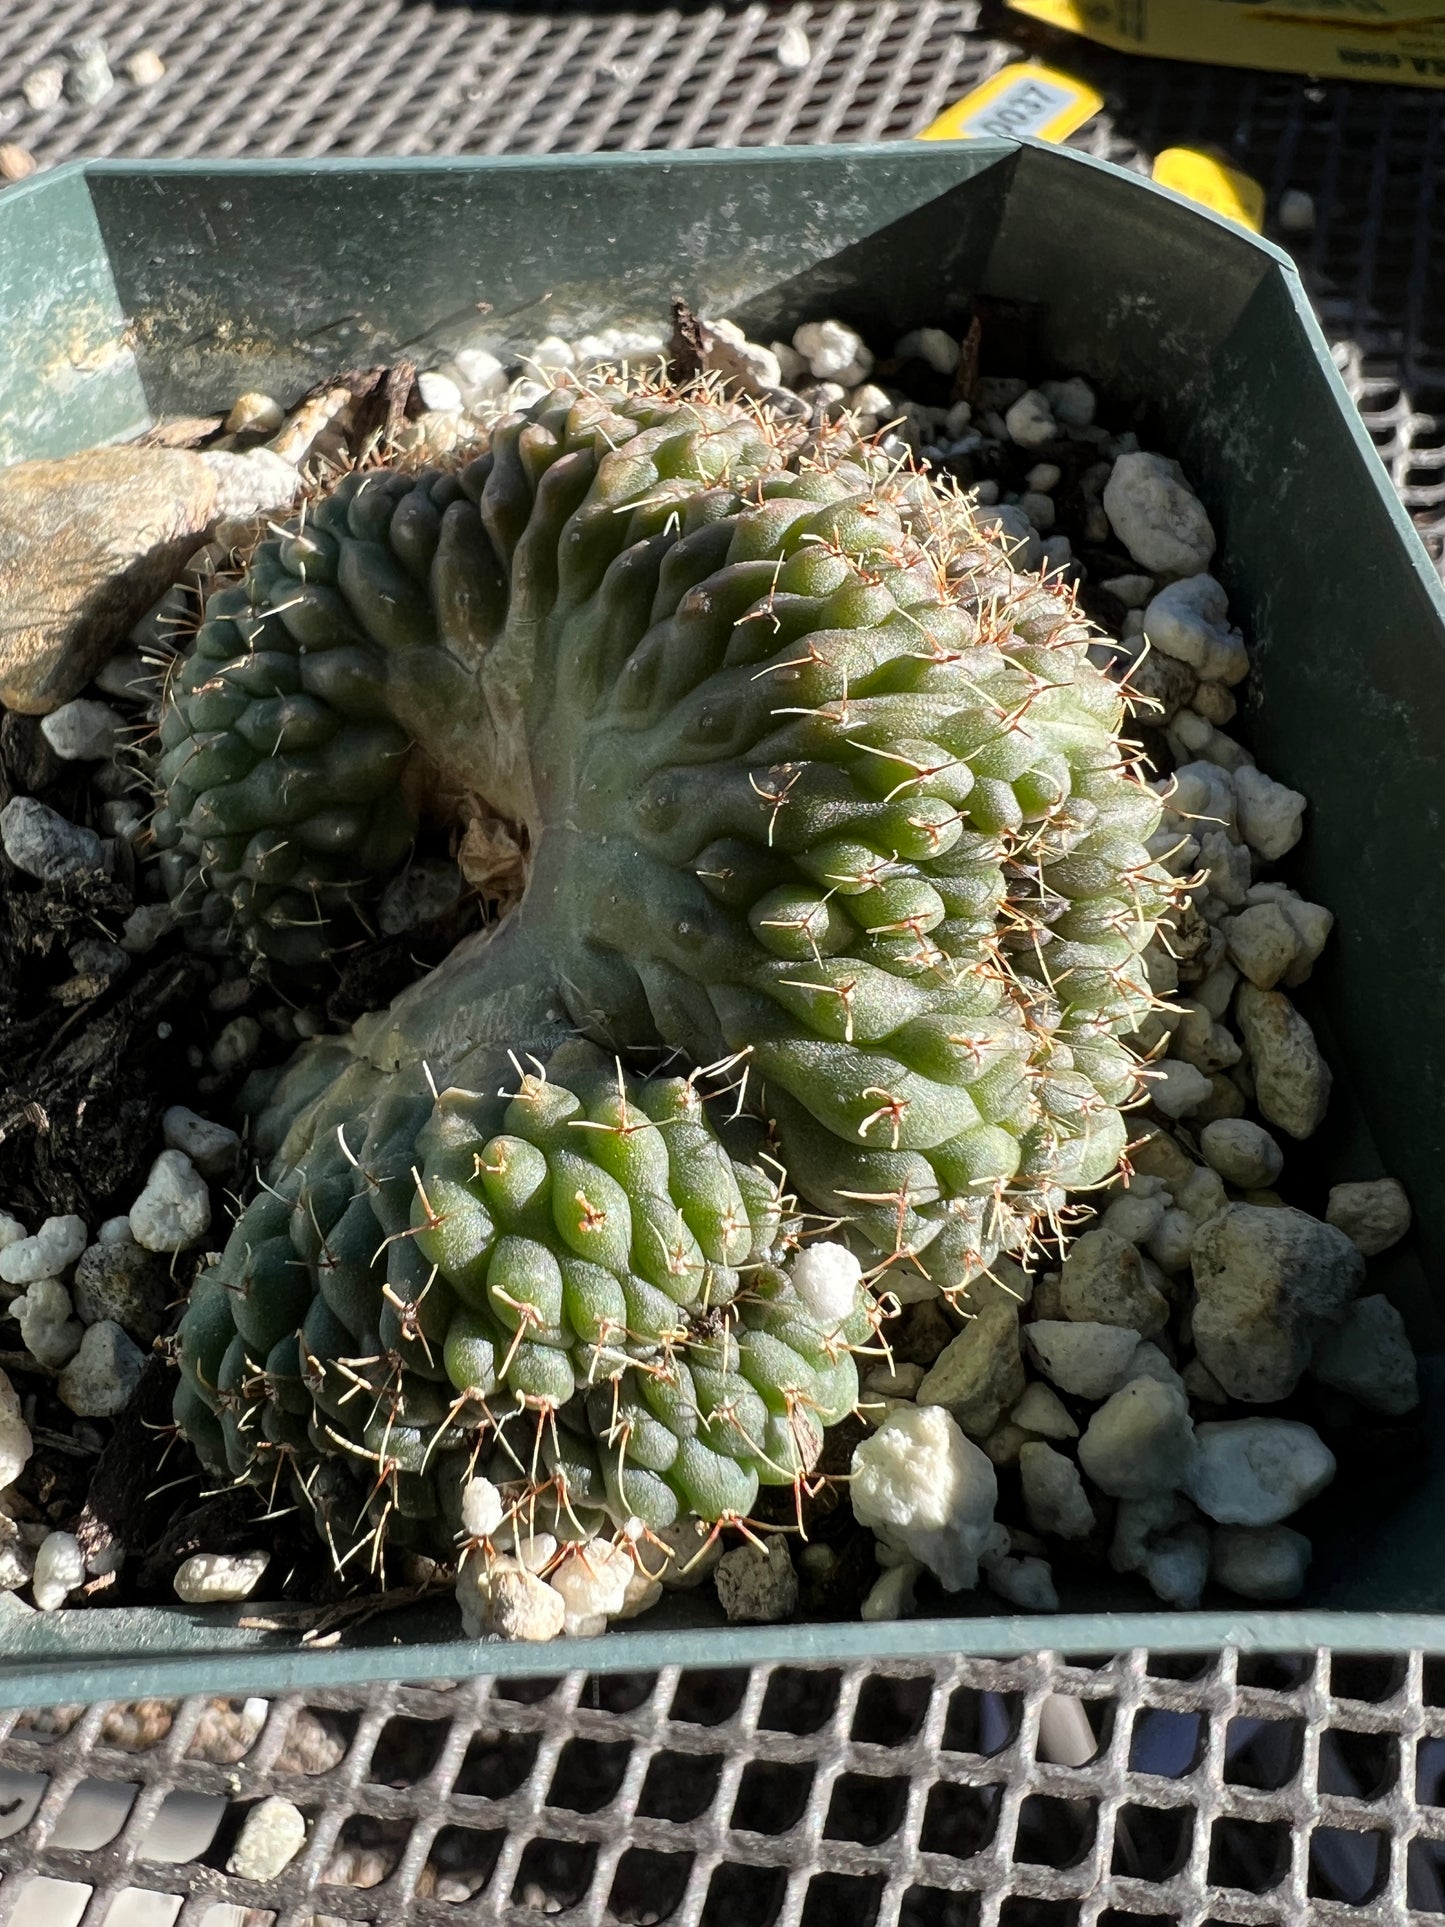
[1008,0,1445,87]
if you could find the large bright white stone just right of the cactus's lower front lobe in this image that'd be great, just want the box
[850,1405,998,1592]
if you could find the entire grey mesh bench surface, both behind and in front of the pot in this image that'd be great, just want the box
[0,0,1445,1927]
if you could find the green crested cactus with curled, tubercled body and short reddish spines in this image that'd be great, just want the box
[158,385,1169,1563]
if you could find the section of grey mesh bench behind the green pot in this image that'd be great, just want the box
[0,0,1445,561]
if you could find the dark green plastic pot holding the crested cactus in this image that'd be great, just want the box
[0,141,1445,1703]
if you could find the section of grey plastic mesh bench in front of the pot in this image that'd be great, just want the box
[0,1651,1445,1927]
